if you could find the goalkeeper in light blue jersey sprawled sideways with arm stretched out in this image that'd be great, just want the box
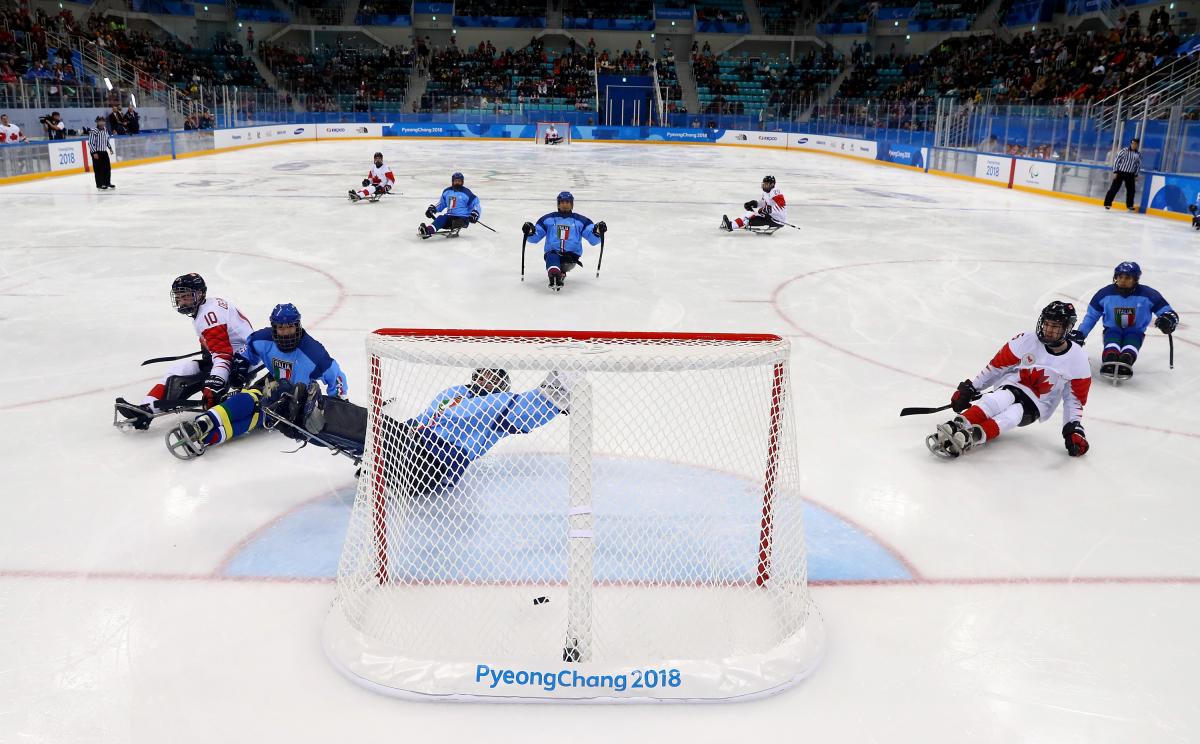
[168,368,575,497]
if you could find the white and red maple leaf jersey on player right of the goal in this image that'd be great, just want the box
[971,331,1092,424]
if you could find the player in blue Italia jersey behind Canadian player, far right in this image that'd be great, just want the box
[1072,260,1180,378]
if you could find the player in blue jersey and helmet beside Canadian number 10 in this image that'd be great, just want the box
[167,302,348,460]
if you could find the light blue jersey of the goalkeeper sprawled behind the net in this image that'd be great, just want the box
[408,385,559,464]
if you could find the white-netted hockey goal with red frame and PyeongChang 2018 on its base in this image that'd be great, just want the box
[324,329,823,702]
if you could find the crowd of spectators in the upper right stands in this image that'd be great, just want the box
[838,21,1180,103]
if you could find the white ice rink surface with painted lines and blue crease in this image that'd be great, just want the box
[0,140,1200,744]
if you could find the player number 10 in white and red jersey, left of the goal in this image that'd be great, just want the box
[116,274,254,428]
